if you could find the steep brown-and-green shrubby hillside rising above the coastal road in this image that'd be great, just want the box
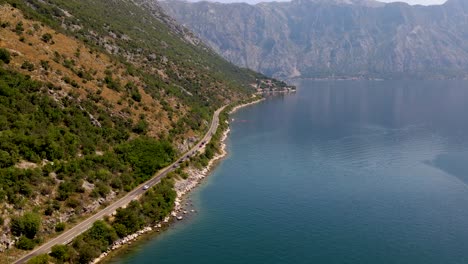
[0,0,288,263]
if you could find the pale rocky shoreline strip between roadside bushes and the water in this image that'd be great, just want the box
[91,98,264,264]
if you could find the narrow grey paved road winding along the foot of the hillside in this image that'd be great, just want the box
[14,106,226,264]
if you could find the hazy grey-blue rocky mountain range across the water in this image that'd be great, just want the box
[160,0,468,78]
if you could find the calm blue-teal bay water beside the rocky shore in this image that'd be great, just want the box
[113,81,468,264]
